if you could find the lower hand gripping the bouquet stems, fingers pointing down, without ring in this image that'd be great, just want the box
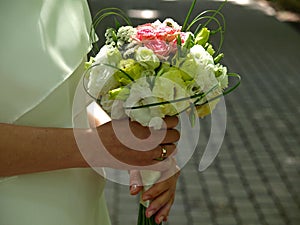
[130,164,180,224]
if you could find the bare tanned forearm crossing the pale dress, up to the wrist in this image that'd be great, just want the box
[0,124,87,176]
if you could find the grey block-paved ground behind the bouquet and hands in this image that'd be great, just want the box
[87,1,300,225]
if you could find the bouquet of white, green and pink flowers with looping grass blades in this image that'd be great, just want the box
[84,0,239,225]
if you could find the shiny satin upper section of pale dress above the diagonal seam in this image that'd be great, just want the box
[0,0,92,123]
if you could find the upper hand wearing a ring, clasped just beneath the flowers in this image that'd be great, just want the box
[97,116,180,169]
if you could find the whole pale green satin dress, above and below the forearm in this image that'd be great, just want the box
[0,0,110,225]
